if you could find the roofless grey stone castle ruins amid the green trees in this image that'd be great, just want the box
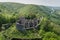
[16,17,40,31]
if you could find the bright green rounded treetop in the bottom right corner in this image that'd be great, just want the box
[43,32,59,40]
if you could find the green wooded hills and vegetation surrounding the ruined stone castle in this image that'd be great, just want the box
[0,3,60,40]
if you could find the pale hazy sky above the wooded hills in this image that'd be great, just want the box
[0,0,60,7]
